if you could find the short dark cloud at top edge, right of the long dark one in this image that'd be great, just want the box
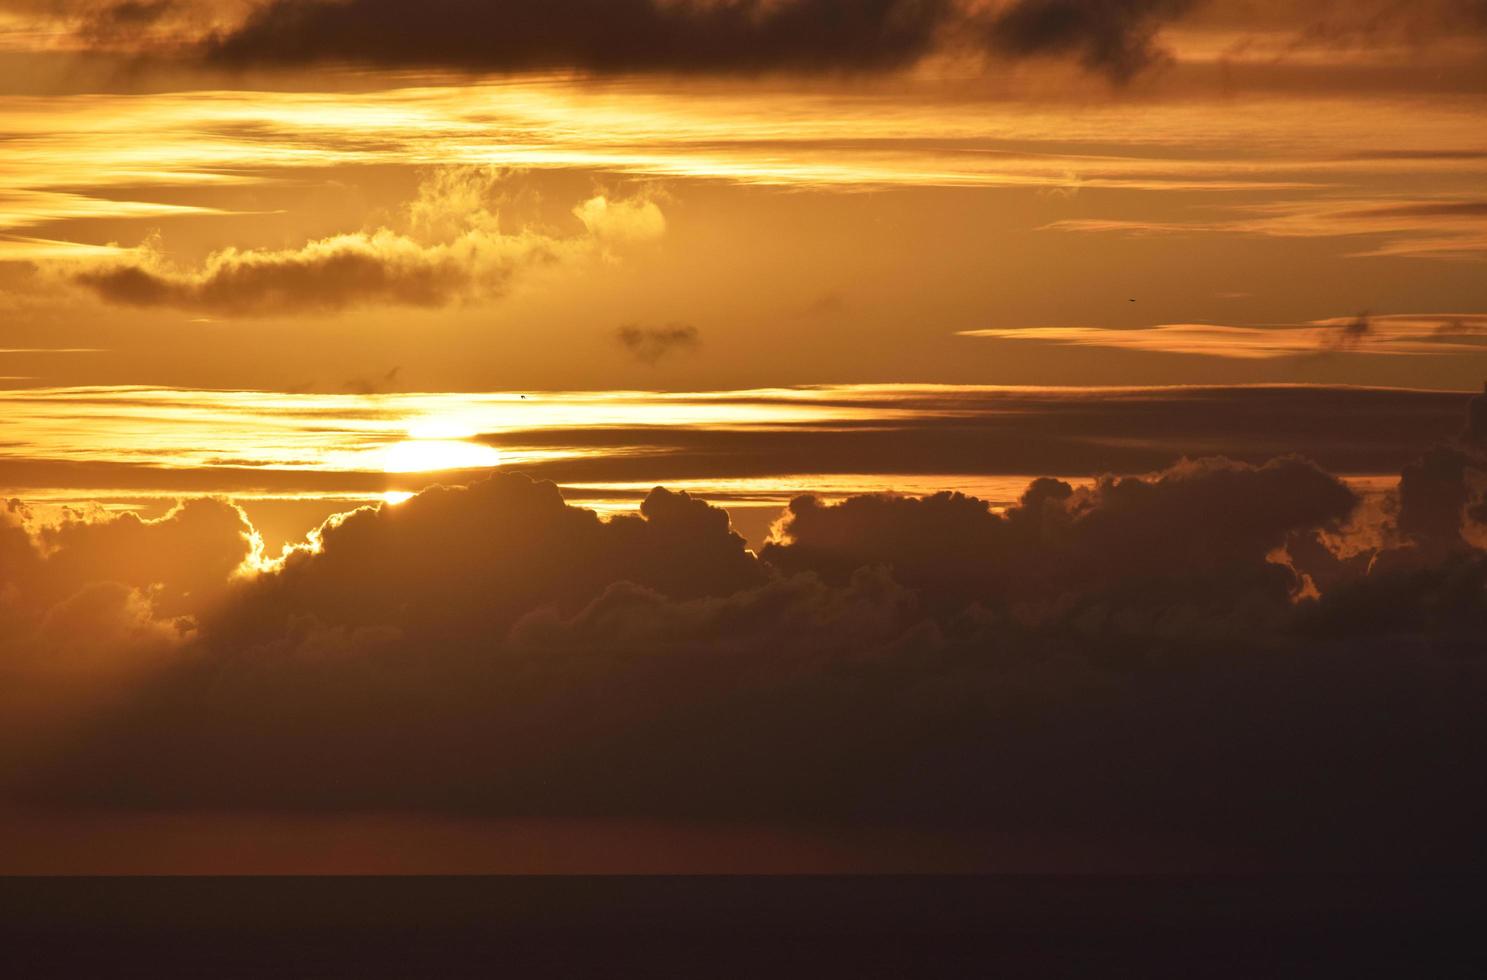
[989,0,1197,82]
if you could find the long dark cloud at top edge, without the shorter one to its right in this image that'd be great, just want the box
[208,0,961,73]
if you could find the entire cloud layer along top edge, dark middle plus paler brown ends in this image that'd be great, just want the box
[0,0,1439,82]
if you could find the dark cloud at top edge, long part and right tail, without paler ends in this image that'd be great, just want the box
[194,0,1194,82]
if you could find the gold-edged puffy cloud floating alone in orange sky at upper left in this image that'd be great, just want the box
[74,168,665,315]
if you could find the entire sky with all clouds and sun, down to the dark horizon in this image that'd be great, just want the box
[0,0,1487,871]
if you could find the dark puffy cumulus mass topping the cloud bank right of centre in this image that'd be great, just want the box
[763,458,1358,605]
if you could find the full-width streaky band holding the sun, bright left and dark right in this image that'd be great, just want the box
[0,385,1468,514]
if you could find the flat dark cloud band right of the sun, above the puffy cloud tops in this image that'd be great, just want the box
[487,387,1469,489]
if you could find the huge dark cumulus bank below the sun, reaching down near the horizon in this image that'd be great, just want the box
[0,389,1487,867]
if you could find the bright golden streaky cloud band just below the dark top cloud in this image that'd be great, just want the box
[0,79,1487,257]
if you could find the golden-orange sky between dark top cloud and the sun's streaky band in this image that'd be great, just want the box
[0,0,1487,393]
